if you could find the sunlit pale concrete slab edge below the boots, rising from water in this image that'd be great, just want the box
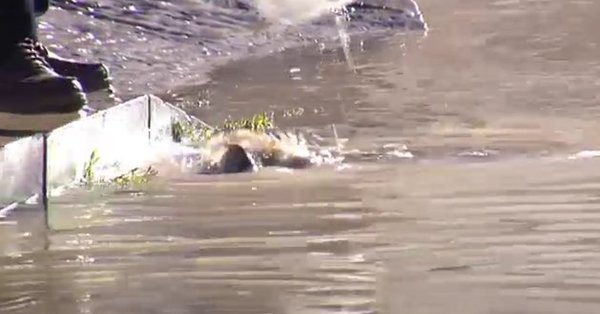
[0,95,191,217]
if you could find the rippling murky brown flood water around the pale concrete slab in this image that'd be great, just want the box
[0,0,600,314]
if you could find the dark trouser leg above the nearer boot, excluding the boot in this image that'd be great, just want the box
[0,0,37,63]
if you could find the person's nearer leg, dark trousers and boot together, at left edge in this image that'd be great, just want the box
[0,0,86,116]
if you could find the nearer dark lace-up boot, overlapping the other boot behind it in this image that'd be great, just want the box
[0,39,86,114]
